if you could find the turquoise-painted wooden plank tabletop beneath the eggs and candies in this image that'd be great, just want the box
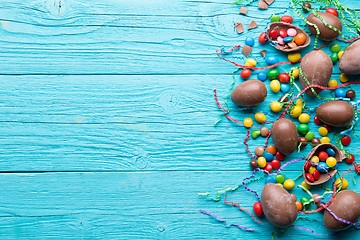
[0,0,360,239]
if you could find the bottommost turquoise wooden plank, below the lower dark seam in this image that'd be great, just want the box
[0,171,359,239]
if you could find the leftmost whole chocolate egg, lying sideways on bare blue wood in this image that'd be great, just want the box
[231,80,267,107]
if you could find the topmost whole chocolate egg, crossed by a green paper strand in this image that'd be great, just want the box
[306,12,342,41]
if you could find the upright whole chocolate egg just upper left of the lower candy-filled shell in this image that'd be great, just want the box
[271,118,298,154]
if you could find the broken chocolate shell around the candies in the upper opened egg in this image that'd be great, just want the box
[266,22,311,52]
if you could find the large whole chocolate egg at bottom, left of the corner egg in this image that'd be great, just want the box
[261,183,298,227]
